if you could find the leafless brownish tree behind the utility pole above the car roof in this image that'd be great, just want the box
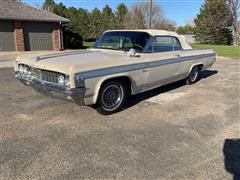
[125,0,175,30]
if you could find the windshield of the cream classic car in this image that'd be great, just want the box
[92,31,150,52]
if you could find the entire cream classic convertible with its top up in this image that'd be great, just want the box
[14,30,216,114]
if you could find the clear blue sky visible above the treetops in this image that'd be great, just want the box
[22,0,204,26]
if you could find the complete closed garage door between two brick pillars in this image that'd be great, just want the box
[24,23,53,51]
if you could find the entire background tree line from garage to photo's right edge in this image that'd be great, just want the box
[43,0,240,48]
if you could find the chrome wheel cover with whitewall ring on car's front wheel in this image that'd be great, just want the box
[101,84,123,111]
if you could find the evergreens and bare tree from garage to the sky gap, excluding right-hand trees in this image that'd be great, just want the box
[43,0,176,48]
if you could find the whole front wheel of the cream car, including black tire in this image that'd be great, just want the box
[98,81,126,114]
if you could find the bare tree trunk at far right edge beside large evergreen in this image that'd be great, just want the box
[227,0,240,46]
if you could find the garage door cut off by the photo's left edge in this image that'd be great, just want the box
[0,21,15,51]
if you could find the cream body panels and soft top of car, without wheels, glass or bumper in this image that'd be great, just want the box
[14,30,215,105]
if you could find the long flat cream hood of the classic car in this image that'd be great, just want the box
[16,50,134,74]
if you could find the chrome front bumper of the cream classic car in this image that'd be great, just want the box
[15,72,85,105]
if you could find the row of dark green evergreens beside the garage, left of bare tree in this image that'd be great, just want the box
[43,0,128,45]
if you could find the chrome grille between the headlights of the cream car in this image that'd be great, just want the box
[32,68,63,83]
